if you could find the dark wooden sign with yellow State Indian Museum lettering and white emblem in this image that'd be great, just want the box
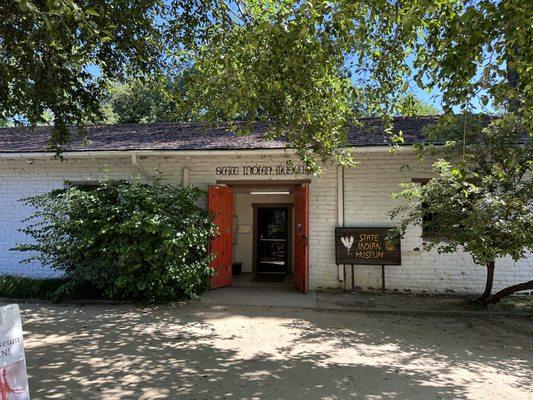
[335,227,402,265]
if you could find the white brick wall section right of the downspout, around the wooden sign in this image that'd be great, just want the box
[345,153,533,293]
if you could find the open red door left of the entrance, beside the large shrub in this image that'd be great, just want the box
[207,185,233,289]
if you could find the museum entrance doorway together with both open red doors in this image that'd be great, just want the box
[208,181,309,293]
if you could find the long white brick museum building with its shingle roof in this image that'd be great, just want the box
[0,119,533,293]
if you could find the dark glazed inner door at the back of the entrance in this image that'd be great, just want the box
[256,207,290,276]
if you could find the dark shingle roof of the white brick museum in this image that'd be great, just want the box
[0,117,436,153]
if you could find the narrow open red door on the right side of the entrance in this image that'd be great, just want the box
[294,184,309,293]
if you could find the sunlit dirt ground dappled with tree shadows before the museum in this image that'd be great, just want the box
[10,303,533,400]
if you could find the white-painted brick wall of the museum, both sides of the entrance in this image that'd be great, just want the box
[0,152,533,292]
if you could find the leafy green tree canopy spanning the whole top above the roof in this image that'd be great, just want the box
[0,0,533,169]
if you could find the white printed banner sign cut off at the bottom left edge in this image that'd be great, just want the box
[0,304,30,400]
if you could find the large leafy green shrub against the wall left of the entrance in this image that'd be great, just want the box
[14,180,216,301]
